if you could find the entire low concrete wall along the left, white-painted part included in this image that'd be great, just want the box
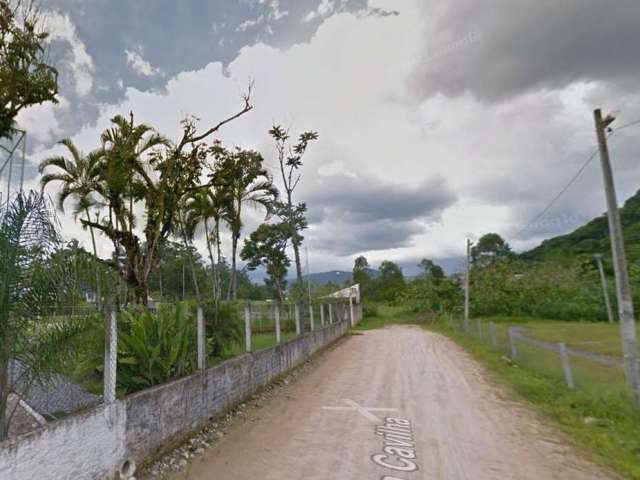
[0,316,348,480]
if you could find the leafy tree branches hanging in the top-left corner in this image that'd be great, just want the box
[0,0,58,139]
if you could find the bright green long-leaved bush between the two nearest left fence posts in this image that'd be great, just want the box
[118,303,197,392]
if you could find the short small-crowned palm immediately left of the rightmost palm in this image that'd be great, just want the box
[185,187,229,304]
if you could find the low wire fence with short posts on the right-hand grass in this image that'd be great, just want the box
[446,312,628,396]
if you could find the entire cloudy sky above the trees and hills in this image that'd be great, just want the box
[5,0,640,273]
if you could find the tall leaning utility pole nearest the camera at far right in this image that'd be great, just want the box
[593,109,640,403]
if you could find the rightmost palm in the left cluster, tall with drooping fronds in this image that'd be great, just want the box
[212,145,278,300]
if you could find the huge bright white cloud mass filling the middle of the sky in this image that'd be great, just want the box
[33,0,640,270]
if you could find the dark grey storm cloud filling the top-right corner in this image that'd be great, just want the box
[411,0,640,101]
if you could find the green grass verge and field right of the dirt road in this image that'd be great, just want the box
[428,319,640,479]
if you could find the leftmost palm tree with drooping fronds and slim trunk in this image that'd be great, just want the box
[38,139,103,306]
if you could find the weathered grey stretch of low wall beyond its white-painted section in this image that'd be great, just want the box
[125,316,347,464]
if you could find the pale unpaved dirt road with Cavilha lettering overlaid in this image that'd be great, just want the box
[171,327,616,480]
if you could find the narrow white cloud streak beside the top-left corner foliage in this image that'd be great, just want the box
[46,12,94,97]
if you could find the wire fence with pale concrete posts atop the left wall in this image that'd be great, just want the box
[3,299,362,436]
